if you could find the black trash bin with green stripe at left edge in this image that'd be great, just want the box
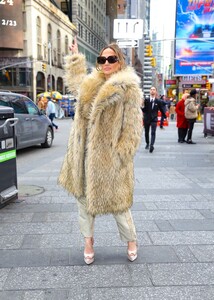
[0,106,18,208]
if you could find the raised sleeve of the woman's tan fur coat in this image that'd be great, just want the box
[64,53,87,97]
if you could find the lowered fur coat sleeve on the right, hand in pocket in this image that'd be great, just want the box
[116,91,142,162]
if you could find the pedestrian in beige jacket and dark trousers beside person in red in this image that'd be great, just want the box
[185,89,198,144]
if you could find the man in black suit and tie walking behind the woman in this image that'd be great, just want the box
[142,86,166,153]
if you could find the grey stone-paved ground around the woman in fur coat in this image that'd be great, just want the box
[0,120,214,300]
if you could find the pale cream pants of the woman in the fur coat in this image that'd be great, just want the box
[77,197,137,242]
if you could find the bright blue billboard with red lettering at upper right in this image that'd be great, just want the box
[174,0,214,75]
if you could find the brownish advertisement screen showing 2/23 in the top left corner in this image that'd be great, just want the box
[0,0,23,49]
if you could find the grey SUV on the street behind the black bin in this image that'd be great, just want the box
[0,91,54,149]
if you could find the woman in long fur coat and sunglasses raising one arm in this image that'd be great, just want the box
[59,39,142,264]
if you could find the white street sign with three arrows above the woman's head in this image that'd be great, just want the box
[113,19,143,40]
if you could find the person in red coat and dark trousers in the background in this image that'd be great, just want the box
[175,93,189,143]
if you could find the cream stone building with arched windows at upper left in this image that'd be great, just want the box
[0,0,77,100]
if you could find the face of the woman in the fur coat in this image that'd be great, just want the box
[99,48,121,79]
